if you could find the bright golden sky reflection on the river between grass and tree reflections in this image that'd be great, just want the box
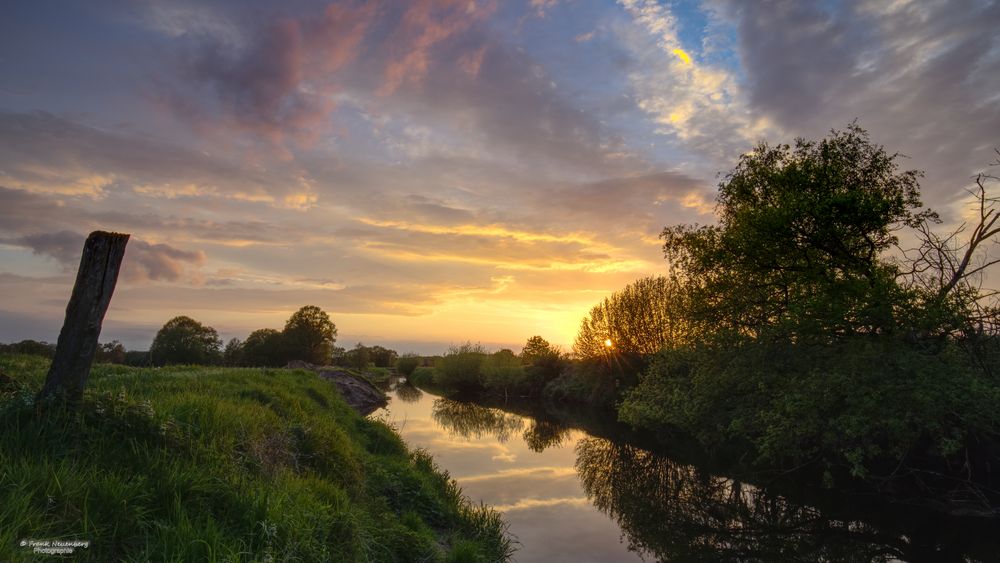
[373,386,639,562]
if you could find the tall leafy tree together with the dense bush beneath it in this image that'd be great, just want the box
[620,125,1000,495]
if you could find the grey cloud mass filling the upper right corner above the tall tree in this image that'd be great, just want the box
[725,0,1000,209]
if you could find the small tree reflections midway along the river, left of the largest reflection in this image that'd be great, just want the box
[431,399,569,452]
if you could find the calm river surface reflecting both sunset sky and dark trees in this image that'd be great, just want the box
[372,384,1000,563]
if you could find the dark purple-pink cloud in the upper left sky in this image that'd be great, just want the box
[160,3,377,146]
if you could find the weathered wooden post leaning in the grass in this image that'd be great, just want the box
[38,231,129,401]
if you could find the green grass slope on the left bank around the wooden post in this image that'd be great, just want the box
[0,355,512,562]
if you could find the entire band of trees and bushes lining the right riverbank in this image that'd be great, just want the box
[408,125,1000,513]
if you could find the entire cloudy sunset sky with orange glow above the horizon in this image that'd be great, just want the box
[0,0,1000,354]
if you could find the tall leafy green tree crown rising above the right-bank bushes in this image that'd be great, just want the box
[661,124,935,339]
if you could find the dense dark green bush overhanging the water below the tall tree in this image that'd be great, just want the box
[620,336,1000,477]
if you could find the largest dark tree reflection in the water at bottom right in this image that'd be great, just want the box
[576,438,984,562]
